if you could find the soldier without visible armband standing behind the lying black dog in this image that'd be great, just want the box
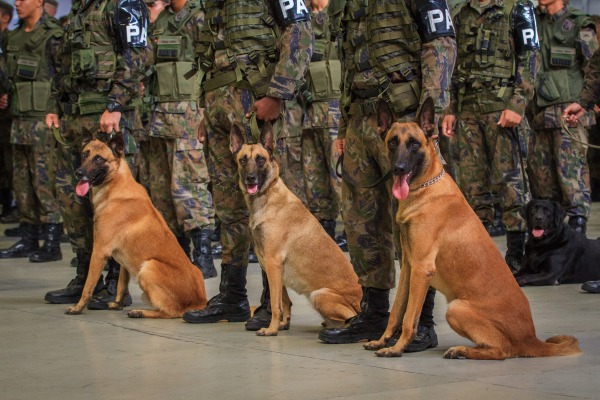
[528,0,599,234]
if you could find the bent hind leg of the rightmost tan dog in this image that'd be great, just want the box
[444,300,508,360]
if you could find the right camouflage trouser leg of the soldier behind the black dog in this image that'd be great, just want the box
[552,126,592,233]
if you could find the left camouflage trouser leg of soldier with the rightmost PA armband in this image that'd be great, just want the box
[456,111,496,226]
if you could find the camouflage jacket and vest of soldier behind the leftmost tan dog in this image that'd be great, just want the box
[52,0,148,114]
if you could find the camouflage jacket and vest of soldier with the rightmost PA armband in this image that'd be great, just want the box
[449,0,539,116]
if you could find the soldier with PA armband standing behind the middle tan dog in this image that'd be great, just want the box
[183,0,312,330]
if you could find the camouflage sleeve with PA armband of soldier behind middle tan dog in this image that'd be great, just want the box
[267,0,313,100]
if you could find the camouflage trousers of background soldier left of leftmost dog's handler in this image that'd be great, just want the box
[12,119,62,225]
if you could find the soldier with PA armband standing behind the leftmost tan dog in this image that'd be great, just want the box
[45,0,148,309]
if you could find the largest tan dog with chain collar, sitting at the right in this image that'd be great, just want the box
[364,98,581,360]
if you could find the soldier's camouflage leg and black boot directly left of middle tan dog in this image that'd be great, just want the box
[183,86,254,323]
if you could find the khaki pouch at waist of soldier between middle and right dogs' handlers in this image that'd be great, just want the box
[308,60,342,101]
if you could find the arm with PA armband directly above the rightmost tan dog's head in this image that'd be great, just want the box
[413,0,456,115]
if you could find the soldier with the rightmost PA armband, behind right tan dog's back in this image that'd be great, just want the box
[442,0,539,272]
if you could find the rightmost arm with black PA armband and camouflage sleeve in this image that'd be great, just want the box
[506,1,540,117]
